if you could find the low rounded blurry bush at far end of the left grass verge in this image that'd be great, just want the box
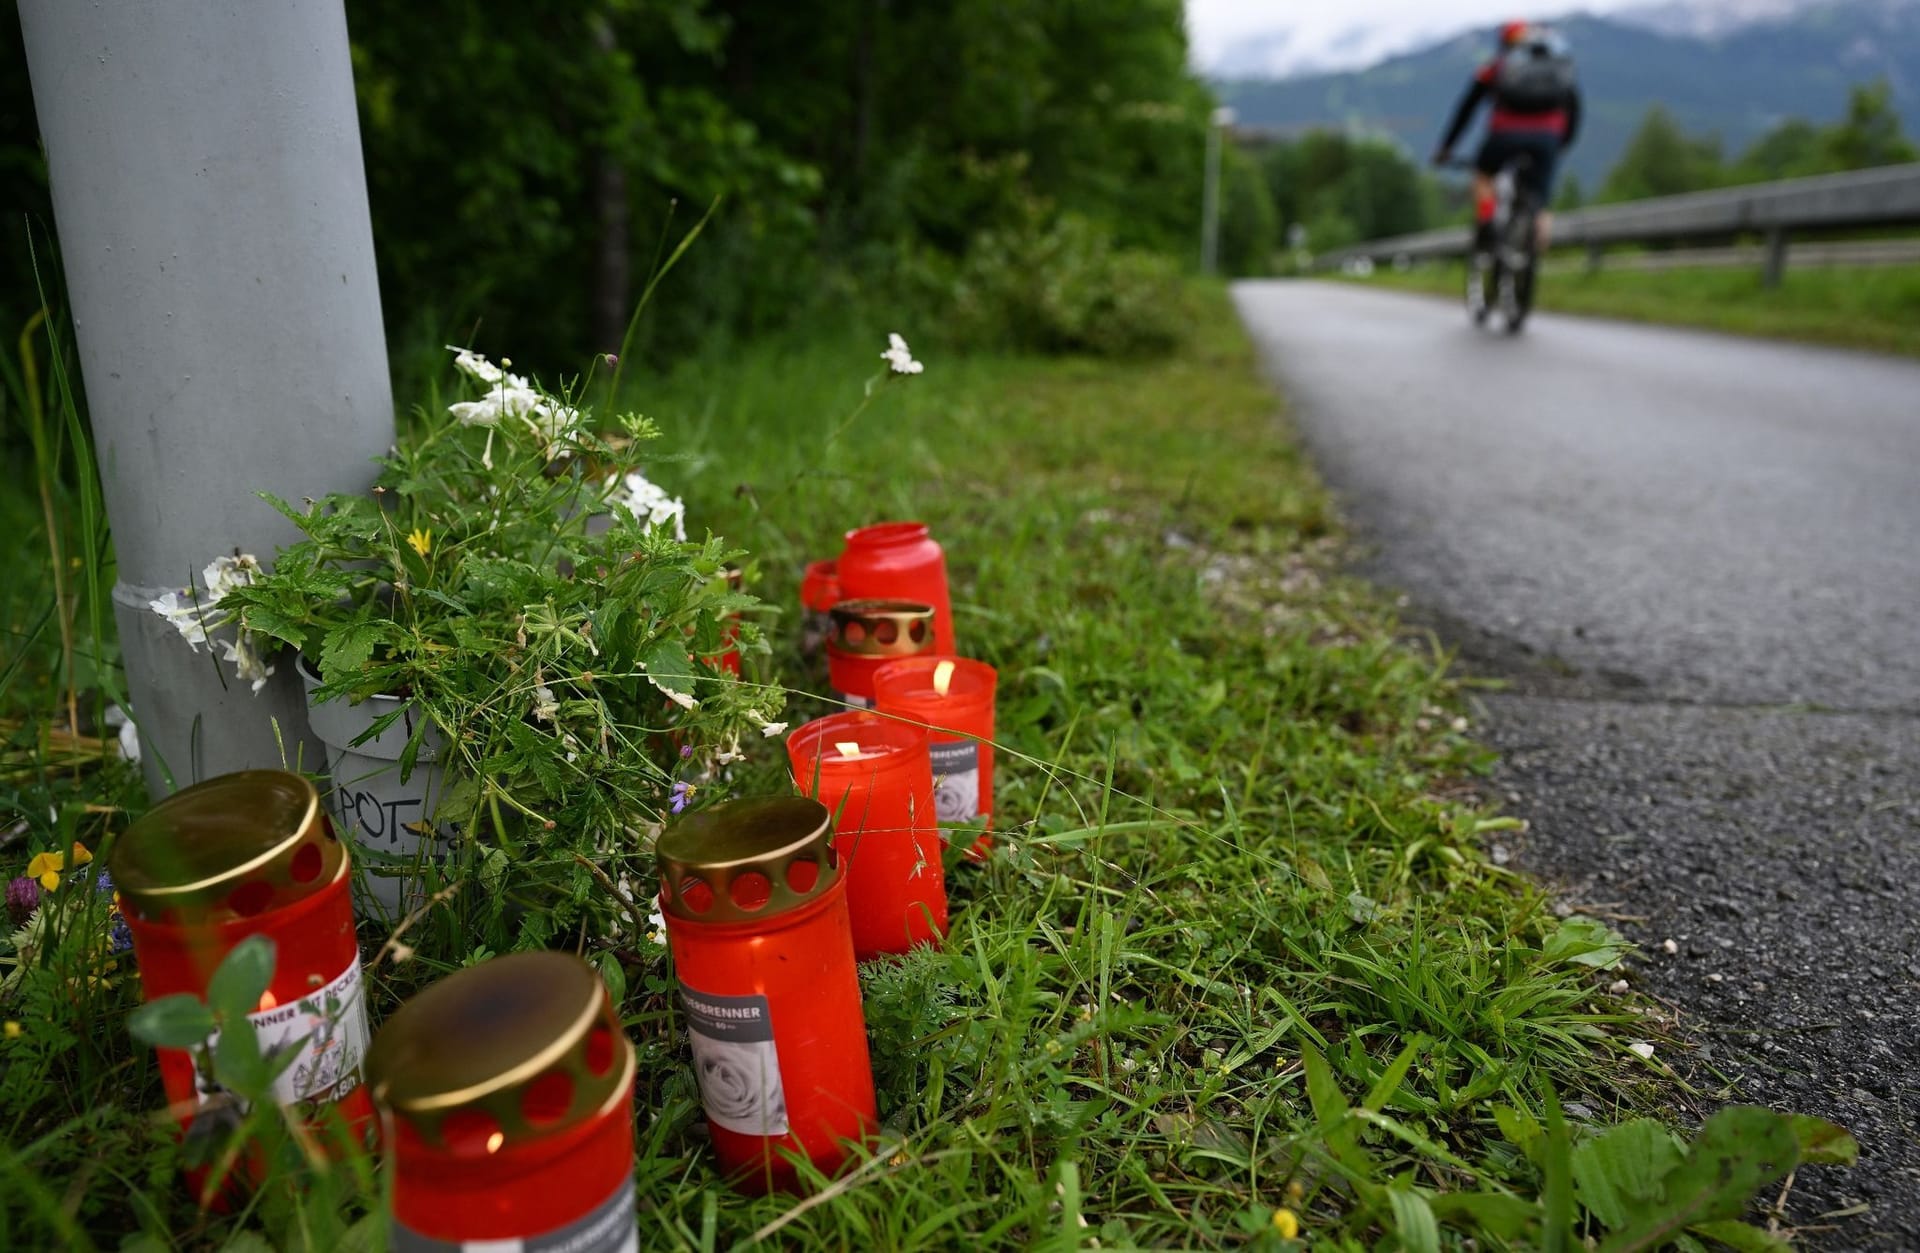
[952,213,1192,357]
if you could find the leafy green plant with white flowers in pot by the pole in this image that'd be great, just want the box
[142,349,783,944]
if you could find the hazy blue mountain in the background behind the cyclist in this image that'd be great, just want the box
[1215,0,1920,188]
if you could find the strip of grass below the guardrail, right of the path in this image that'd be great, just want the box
[1361,253,1920,357]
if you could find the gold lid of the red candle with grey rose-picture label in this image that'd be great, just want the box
[653,796,839,923]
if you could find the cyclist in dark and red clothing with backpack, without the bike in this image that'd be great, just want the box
[1434,21,1580,249]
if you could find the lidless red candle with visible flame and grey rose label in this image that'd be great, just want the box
[874,652,996,852]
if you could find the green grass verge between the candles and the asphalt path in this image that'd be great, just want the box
[0,287,1835,1249]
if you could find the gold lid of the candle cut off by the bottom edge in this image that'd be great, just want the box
[367,952,634,1153]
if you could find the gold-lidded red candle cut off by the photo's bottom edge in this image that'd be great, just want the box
[367,952,637,1253]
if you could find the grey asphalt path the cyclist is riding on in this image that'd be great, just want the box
[1235,282,1920,1249]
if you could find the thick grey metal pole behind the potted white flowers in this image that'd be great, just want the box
[19,0,394,796]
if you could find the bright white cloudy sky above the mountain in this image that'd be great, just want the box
[1187,0,1647,69]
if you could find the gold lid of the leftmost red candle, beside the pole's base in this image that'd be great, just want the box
[108,769,348,925]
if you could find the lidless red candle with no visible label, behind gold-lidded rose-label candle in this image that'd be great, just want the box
[787,710,947,961]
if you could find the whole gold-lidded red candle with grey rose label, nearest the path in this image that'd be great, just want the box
[655,796,879,1194]
